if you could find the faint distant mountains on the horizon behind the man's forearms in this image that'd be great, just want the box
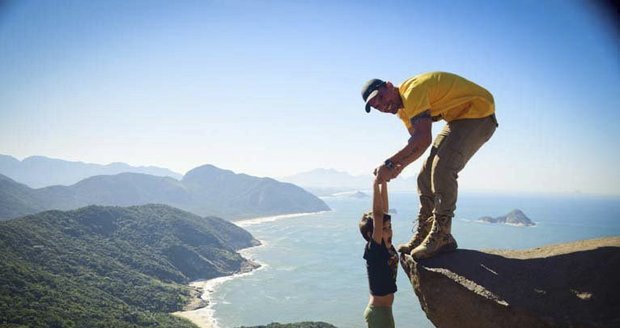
[281,169,417,196]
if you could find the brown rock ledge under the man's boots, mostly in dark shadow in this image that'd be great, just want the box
[401,237,620,328]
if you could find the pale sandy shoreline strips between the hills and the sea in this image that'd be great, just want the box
[171,211,322,328]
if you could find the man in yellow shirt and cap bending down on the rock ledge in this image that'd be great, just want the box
[362,72,498,259]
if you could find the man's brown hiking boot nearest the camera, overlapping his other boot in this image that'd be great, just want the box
[411,216,458,260]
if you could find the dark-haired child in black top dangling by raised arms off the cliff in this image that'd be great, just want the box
[359,179,398,328]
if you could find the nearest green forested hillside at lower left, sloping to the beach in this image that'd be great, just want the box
[0,205,258,327]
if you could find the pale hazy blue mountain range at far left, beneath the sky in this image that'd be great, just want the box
[0,154,182,188]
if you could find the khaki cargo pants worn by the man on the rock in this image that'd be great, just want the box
[418,115,498,219]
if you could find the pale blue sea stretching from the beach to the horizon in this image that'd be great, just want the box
[211,193,620,328]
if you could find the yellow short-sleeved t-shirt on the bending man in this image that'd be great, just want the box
[396,72,495,129]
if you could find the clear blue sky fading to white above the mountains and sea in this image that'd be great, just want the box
[0,0,620,195]
